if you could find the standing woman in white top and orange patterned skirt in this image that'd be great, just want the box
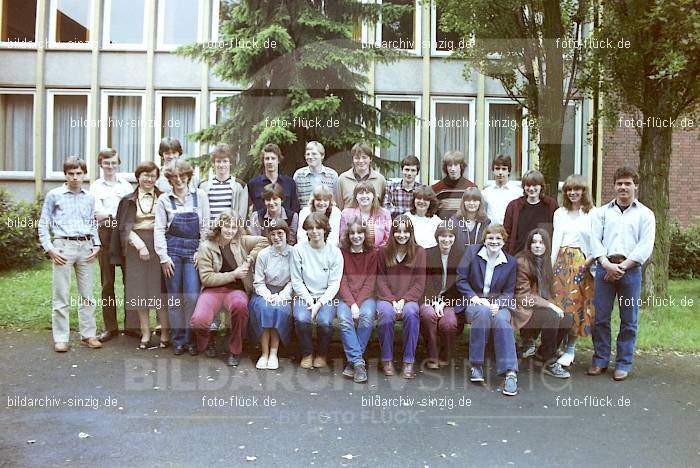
[548,175,595,367]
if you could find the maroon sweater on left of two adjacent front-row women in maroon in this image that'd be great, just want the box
[339,249,379,306]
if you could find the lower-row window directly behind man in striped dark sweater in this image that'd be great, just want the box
[430,98,475,181]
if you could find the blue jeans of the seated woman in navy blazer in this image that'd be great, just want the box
[466,304,518,374]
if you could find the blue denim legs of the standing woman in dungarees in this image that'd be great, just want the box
[165,256,201,346]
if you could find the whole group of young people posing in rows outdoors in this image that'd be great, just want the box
[39,138,655,395]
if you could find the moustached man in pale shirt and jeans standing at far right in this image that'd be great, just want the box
[587,166,656,380]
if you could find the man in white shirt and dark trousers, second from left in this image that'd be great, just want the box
[90,148,139,343]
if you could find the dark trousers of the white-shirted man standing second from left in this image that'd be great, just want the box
[97,226,140,331]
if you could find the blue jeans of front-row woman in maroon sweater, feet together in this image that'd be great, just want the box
[338,297,376,366]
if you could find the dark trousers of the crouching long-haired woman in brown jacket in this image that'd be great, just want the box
[520,307,574,362]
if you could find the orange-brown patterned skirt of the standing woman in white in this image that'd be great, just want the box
[552,247,595,336]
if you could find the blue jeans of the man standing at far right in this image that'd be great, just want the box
[593,265,642,372]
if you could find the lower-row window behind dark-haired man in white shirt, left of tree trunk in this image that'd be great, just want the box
[484,99,528,180]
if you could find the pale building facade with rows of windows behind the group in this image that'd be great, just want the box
[0,0,697,227]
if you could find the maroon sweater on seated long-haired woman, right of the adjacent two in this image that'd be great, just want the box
[377,246,425,302]
